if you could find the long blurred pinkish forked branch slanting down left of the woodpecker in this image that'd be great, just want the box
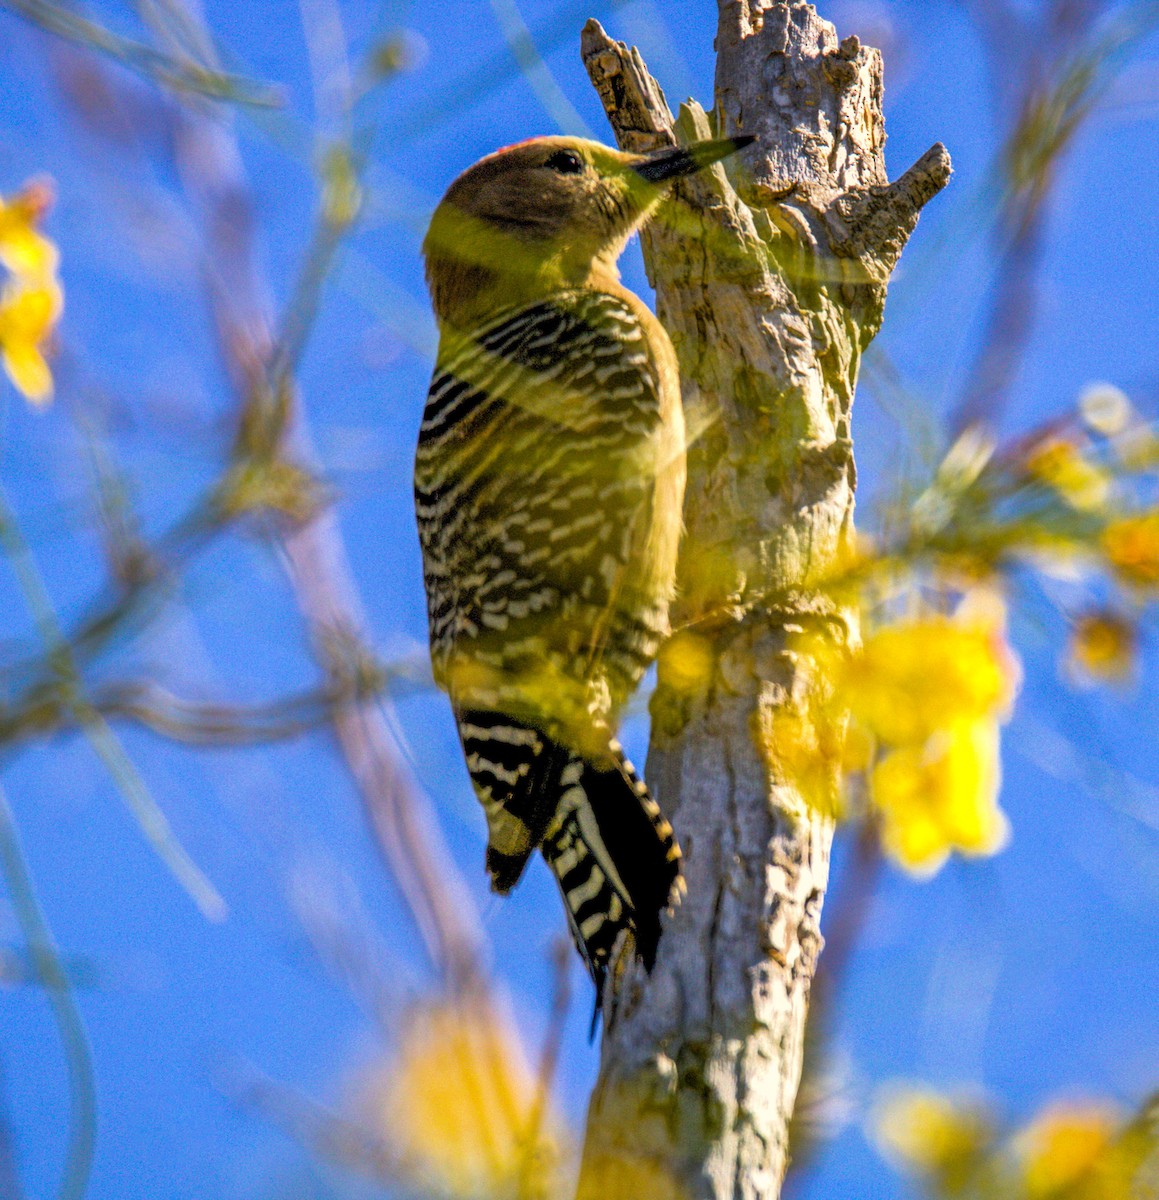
[149,4,482,988]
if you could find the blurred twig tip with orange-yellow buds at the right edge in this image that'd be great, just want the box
[907,396,1159,684]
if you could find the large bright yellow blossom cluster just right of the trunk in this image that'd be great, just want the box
[769,589,1019,876]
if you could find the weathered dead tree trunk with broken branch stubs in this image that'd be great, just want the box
[578,0,950,1200]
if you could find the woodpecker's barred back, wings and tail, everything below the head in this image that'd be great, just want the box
[415,292,683,983]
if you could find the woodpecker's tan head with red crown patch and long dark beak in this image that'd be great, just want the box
[422,137,755,326]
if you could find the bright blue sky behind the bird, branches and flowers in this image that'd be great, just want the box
[0,0,1159,1200]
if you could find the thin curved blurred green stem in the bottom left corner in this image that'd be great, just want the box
[0,791,97,1200]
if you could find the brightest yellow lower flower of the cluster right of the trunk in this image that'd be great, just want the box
[870,719,1010,876]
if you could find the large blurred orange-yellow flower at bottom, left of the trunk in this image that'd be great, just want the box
[378,1001,554,1198]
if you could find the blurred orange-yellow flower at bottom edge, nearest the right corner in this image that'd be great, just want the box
[1015,1103,1119,1200]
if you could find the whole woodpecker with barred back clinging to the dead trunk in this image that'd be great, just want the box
[415,137,752,1006]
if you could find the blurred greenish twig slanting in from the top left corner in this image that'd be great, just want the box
[0,0,283,108]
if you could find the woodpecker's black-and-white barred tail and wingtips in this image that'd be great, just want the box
[458,712,680,1009]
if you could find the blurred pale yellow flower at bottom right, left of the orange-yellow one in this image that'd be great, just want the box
[873,1085,991,1181]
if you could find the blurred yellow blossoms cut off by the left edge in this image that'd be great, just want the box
[0,181,64,404]
